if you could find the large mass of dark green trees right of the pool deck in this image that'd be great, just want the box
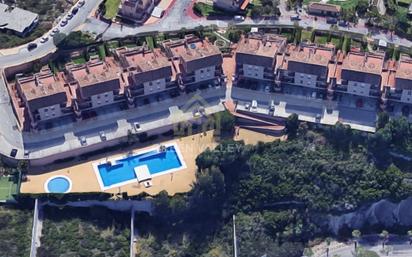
[132,116,412,257]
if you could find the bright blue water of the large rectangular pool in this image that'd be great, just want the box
[97,146,182,187]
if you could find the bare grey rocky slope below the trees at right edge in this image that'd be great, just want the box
[327,197,412,234]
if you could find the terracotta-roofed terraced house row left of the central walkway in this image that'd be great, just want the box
[9,35,223,130]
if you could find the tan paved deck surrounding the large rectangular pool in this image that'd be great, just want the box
[20,131,217,195]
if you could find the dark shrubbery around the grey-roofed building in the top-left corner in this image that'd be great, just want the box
[0,0,71,48]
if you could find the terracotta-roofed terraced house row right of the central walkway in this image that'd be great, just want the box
[234,34,412,118]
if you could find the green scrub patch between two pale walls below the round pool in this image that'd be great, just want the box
[38,207,130,257]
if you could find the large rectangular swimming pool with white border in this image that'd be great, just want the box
[94,145,185,190]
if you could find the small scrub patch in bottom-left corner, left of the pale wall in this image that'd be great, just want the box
[0,207,33,257]
